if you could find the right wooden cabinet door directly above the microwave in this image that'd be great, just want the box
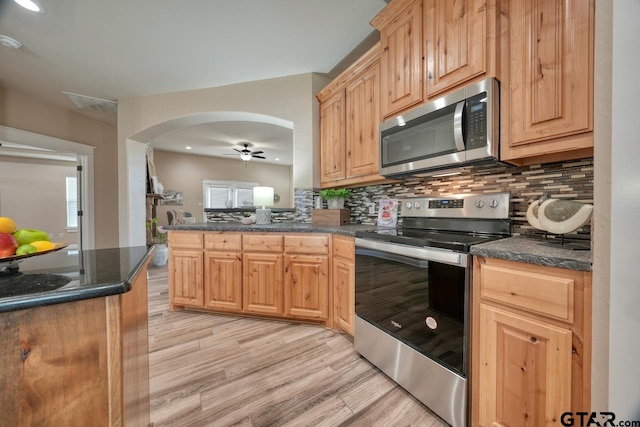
[424,0,495,98]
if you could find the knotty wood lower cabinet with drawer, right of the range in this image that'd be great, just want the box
[471,257,591,427]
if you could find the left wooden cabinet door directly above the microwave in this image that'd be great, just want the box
[371,0,424,118]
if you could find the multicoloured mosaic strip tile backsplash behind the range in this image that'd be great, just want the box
[324,158,593,238]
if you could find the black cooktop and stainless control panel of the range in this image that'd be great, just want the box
[356,193,511,252]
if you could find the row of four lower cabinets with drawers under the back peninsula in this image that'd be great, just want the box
[169,231,333,326]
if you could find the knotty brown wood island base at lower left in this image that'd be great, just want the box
[0,246,151,427]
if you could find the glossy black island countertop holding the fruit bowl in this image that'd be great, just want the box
[0,246,155,313]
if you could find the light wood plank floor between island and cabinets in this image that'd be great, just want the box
[149,266,447,427]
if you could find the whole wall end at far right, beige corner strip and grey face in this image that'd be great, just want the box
[591,0,640,418]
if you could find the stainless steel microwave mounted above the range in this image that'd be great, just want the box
[380,78,500,178]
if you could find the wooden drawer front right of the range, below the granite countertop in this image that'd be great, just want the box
[480,265,575,323]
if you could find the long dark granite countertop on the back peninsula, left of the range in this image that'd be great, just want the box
[163,222,388,236]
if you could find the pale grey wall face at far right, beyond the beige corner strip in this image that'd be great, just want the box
[596,0,640,421]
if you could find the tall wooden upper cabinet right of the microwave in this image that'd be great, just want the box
[501,0,594,164]
